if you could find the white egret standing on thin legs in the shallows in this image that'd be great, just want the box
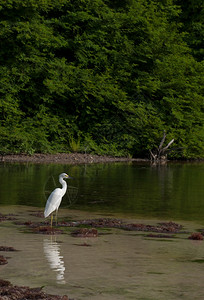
[44,173,71,227]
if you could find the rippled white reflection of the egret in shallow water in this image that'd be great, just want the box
[43,237,66,284]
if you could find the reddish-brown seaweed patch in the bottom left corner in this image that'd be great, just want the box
[0,279,73,300]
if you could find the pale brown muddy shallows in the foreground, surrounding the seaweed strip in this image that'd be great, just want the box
[0,206,204,300]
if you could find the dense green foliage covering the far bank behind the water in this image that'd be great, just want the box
[0,0,204,158]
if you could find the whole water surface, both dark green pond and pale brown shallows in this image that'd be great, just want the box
[0,163,204,300]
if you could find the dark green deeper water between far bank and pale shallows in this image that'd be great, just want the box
[0,163,204,223]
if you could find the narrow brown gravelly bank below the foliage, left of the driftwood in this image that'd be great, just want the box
[1,153,150,164]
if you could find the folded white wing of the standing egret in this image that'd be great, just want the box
[44,188,62,218]
